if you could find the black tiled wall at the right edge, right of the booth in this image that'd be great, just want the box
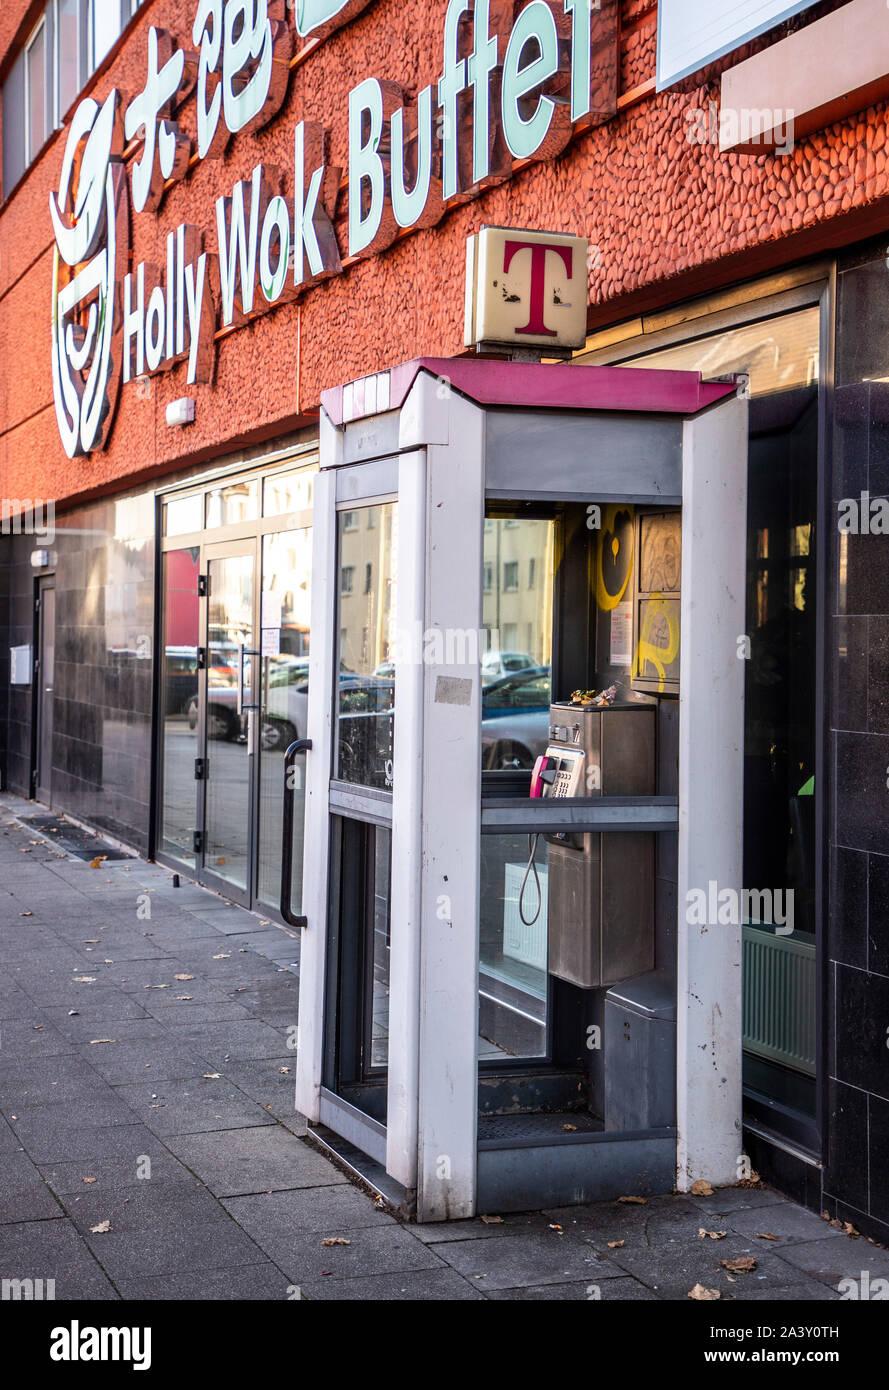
[824,247,889,1243]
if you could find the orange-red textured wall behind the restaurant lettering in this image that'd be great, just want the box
[0,0,889,500]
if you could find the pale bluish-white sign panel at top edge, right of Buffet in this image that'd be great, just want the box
[657,0,815,92]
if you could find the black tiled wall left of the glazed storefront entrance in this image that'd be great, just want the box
[0,493,154,852]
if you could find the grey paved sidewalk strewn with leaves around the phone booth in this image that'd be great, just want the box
[0,794,889,1302]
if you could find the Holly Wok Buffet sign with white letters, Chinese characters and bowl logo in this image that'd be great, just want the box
[50,0,617,457]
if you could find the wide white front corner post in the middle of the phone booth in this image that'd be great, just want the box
[417,389,485,1222]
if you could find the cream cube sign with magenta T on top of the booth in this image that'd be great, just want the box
[464,227,588,349]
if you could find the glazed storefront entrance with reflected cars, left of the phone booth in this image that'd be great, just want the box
[156,455,315,915]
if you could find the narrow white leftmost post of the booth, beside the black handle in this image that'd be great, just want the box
[296,410,342,1123]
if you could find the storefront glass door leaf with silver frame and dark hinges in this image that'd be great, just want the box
[200,541,258,906]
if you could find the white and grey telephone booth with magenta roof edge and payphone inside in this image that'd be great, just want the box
[296,359,747,1222]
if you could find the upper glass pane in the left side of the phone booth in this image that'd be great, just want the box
[333,502,394,791]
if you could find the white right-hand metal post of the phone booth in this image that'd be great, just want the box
[676,398,747,1191]
